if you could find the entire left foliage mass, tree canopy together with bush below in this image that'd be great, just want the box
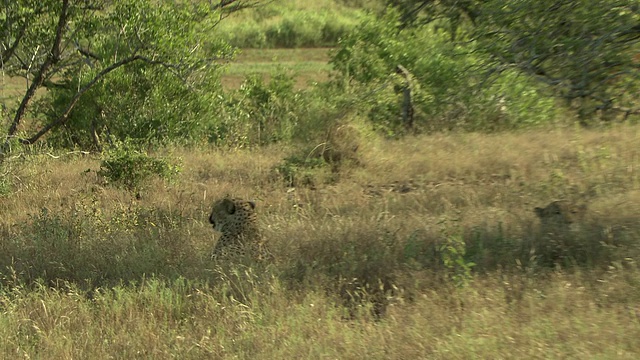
[2,0,235,146]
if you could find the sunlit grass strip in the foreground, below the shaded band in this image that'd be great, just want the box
[0,275,640,359]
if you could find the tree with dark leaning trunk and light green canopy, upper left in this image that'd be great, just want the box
[0,0,257,150]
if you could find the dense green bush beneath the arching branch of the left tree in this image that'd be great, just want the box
[48,64,225,149]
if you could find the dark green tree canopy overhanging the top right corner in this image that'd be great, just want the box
[388,0,640,123]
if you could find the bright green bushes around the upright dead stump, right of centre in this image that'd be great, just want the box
[331,11,554,135]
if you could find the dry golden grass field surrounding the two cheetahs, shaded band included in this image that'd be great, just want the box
[0,126,640,359]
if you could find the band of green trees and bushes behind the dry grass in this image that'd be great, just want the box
[2,0,640,153]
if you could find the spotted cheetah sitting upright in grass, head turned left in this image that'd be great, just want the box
[209,196,260,258]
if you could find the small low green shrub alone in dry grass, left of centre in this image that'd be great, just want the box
[98,146,180,191]
